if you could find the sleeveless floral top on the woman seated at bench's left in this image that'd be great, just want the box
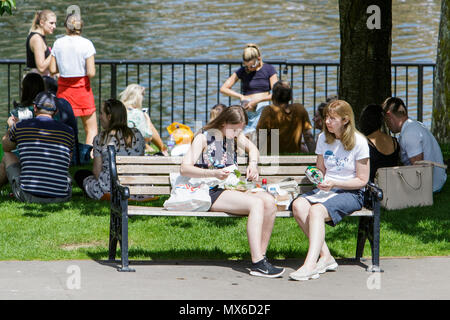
[195,131,237,169]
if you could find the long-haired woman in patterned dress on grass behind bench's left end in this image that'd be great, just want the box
[74,99,145,199]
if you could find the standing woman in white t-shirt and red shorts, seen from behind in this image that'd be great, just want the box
[50,13,98,145]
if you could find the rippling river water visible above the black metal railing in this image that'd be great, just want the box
[0,0,441,135]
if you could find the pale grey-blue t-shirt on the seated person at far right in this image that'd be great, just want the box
[398,119,447,191]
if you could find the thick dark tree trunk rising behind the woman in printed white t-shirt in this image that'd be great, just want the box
[339,0,392,123]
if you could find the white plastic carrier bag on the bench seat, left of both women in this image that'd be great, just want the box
[164,173,211,211]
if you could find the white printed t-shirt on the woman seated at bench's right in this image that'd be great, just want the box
[316,133,370,181]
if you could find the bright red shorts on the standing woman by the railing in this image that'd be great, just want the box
[56,76,95,117]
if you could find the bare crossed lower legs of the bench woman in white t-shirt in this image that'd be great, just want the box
[292,198,333,271]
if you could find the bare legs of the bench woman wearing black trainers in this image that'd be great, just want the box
[211,191,277,263]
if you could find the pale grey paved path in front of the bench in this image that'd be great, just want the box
[0,256,450,300]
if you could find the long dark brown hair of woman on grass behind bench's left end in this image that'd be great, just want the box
[100,99,136,149]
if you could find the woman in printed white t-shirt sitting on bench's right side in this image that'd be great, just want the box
[290,100,370,280]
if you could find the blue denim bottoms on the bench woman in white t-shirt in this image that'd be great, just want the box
[289,189,364,227]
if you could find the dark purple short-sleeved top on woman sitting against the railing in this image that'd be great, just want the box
[236,63,277,95]
